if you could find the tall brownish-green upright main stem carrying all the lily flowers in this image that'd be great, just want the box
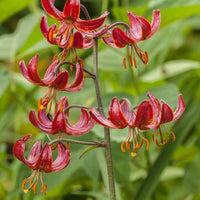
[93,38,116,200]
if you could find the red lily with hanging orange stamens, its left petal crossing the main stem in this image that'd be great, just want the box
[90,98,153,156]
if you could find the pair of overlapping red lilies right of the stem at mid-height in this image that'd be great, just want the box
[90,93,185,156]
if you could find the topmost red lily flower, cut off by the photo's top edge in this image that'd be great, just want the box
[42,0,109,35]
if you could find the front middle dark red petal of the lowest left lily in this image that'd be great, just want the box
[34,143,52,172]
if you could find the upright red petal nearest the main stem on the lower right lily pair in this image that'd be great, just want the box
[108,97,129,128]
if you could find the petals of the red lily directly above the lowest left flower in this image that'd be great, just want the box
[29,97,95,136]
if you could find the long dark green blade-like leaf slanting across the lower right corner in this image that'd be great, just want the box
[135,106,200,200]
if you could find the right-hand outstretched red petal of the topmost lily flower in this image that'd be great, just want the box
[73,11,109,31]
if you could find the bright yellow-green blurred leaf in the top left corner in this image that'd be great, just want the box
[0,0,35,23]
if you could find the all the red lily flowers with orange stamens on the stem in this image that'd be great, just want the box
[13,0,185,194]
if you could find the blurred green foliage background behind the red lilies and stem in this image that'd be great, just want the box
[0,0,200,200]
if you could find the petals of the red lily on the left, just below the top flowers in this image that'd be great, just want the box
[19,55,85,92]
